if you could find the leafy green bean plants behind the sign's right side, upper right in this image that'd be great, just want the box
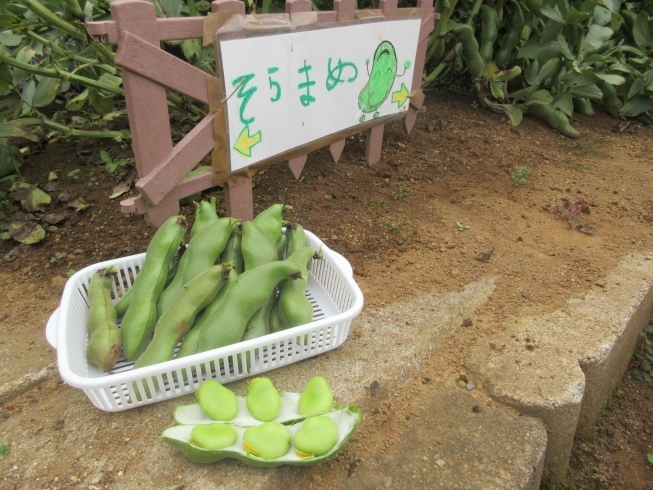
[424,0,653,137]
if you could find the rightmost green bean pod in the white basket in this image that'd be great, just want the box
[279,247,322,328]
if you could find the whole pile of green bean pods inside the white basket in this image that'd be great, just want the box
[86,199,322,372]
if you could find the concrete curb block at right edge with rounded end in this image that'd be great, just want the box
[467,254,653,480]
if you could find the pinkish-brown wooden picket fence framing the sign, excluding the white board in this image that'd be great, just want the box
[88,0,432,227]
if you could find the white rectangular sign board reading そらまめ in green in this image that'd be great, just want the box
[218,19,421,172]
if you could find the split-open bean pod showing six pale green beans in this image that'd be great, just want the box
[161,376,361,466]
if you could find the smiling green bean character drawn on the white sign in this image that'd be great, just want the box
[358,41,410,122]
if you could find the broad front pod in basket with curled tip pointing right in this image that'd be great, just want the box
[198,261,302,352]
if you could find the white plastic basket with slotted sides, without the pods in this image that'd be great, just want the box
[46,232,363,412]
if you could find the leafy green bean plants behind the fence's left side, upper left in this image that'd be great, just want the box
[0,0,215,173]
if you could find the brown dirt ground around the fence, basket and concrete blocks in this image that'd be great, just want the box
[0,94,653,489]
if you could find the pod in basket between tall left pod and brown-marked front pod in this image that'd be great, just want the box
[156,218,237,319]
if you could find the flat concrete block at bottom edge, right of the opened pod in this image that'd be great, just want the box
[344,385,546,490]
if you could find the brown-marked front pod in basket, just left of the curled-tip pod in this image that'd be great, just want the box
[134,265,230,369]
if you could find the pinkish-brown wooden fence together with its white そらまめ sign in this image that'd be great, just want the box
[89,0,438,226]
